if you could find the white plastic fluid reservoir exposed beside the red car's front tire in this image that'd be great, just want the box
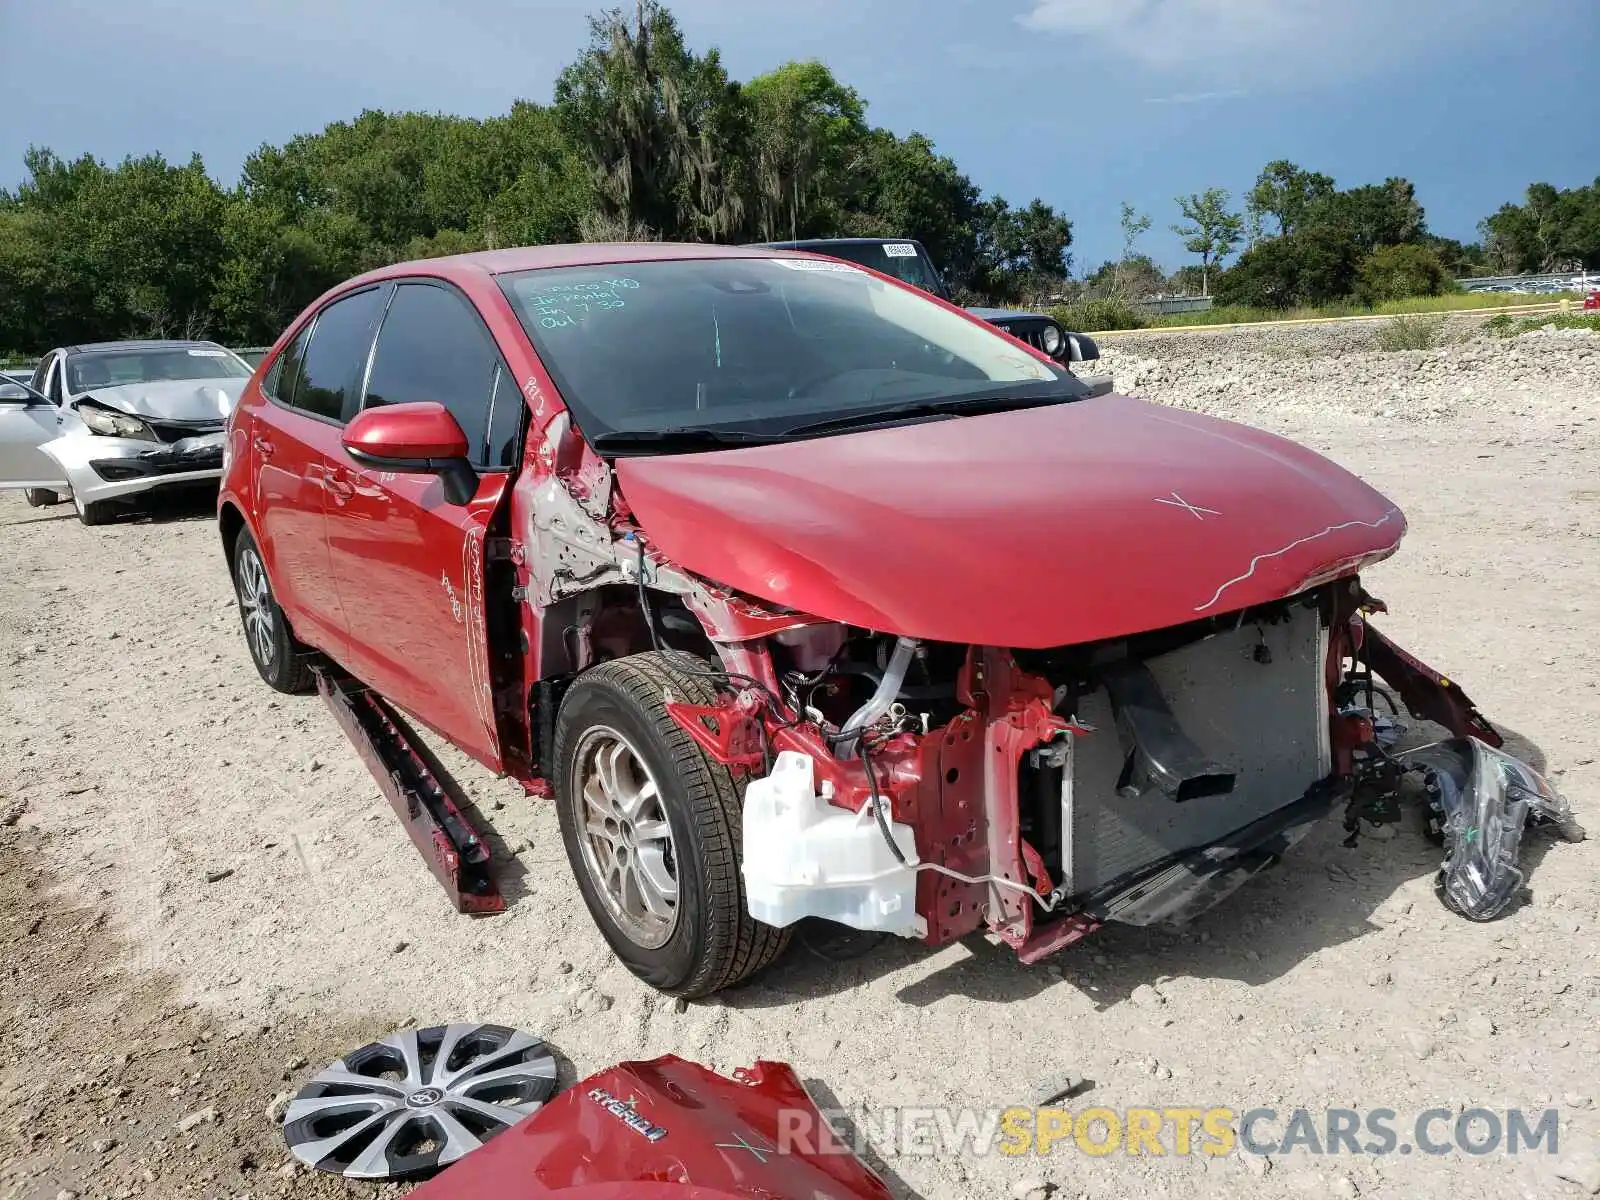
[744,750,928,938]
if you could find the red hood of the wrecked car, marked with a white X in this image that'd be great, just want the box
[616,395,1405,648]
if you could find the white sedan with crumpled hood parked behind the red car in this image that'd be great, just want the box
[0,341,251,525]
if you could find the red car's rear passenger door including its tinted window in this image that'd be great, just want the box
[248,285,387,667]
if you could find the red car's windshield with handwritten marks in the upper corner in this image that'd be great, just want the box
[499,258,1086,440]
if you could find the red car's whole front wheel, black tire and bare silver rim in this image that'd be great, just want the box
[554,653,789,997]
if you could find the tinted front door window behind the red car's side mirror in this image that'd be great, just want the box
[364,283,508,467]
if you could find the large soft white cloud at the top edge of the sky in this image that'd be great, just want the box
[1016,0,1516,82]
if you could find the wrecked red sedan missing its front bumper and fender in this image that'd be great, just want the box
[219,243,1565,995]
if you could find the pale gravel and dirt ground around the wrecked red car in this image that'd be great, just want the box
[0,326,1600,1200]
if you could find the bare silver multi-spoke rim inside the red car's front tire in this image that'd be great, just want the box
[573,726,678,950]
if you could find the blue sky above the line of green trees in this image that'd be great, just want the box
[0,0,1600,269]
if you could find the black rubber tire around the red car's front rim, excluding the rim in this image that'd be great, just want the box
[554,653,789,998]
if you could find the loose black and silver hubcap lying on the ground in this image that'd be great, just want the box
[283,1024,558,1179]
